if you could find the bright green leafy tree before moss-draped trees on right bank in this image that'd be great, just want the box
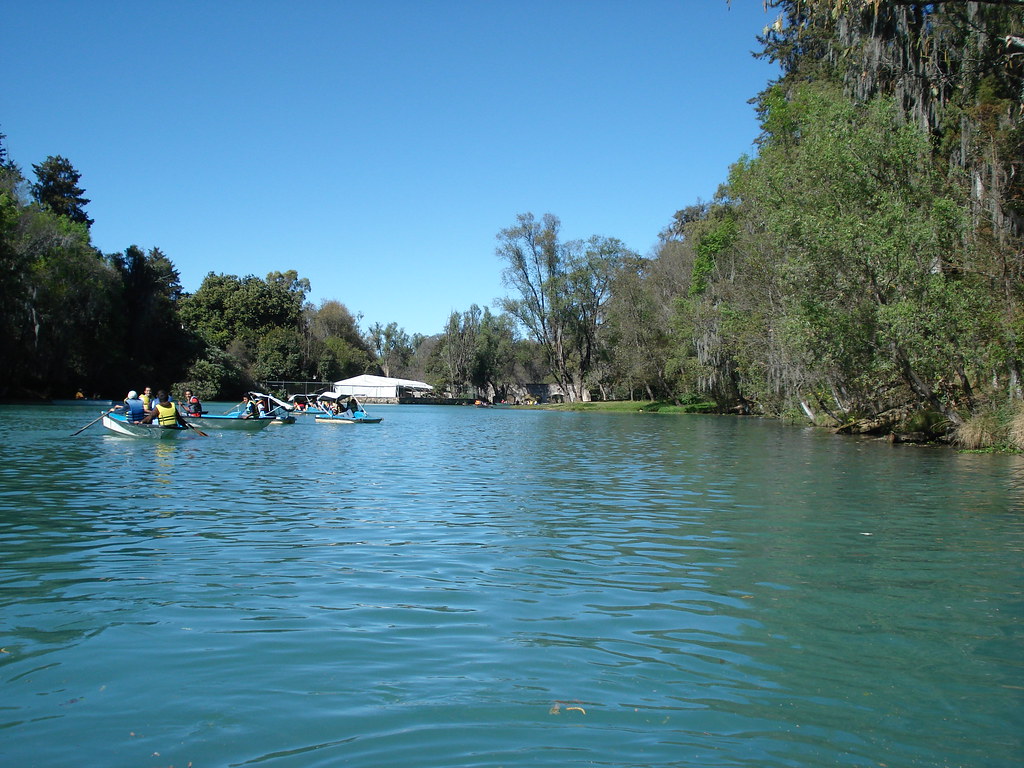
[716,86,984,421]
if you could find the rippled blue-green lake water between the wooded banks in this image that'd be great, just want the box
[0,406,1024,768]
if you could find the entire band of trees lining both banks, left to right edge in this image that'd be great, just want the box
[0,0,1024,447]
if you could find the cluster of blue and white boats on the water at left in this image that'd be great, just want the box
[88,392,383,439]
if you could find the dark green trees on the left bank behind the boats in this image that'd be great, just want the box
[0,148,373,398]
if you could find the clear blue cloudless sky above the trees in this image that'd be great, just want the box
[0,0,777,334]
